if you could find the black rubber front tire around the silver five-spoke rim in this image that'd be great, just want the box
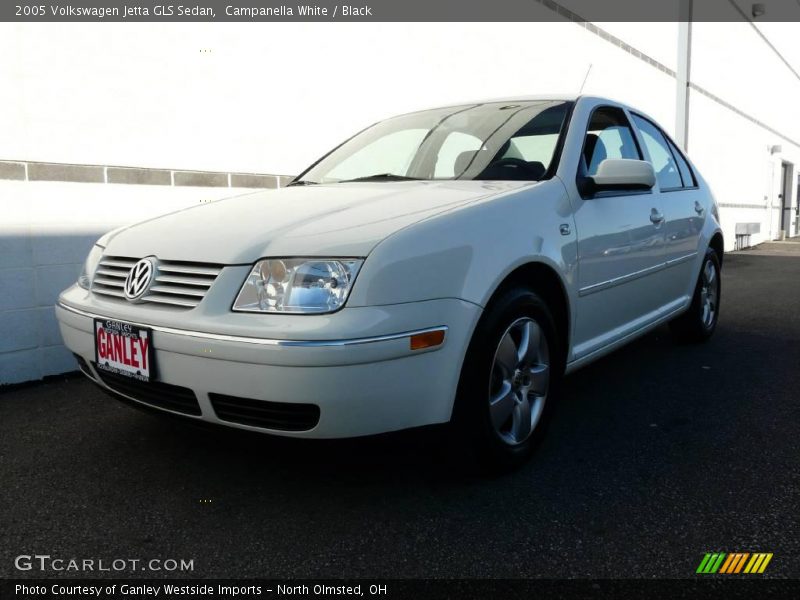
[453,287,564,473]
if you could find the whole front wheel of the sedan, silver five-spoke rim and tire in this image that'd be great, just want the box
[455,288,564,471]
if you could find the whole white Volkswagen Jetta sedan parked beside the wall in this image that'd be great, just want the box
[56,96,723,467]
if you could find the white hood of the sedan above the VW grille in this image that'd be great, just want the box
[105,181,531,264]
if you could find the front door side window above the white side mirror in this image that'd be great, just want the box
[583,106,642,176]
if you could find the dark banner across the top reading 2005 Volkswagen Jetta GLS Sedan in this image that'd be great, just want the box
[0,0,800,23]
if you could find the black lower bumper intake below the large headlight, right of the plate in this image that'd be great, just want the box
[208,394,319,431]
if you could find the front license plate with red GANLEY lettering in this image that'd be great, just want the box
[94,319,155,381]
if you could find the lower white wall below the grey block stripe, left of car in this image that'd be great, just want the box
[0,180,253,384]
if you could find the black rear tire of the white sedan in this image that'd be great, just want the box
[669,248,722,343]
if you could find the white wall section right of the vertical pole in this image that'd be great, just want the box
[689,15,800,249]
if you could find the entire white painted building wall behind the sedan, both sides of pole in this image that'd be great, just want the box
[0,19,800,383]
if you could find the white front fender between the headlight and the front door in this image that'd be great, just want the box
[348,179,577,306]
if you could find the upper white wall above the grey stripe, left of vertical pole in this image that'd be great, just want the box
[0,23,676,173]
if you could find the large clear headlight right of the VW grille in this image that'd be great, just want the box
[233,258,364,314]
